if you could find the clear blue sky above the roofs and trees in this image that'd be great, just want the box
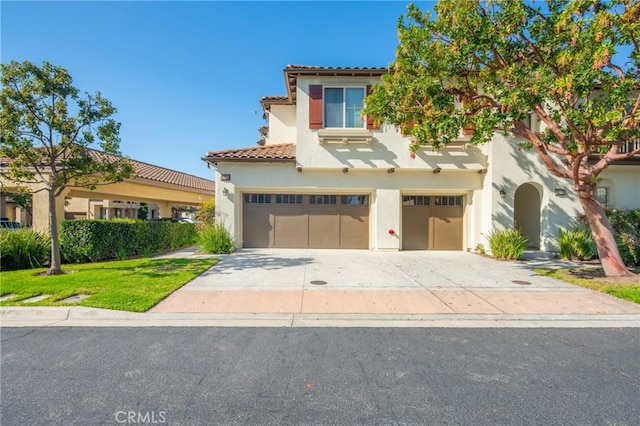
[0,0,433,179]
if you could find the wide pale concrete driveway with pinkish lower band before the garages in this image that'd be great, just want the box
[151,249,640,315]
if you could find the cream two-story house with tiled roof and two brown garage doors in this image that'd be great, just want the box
[203,66,640,251]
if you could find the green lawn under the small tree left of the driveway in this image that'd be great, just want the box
[0,258,218,312]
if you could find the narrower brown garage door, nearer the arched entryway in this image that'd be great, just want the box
[402,195,463,250]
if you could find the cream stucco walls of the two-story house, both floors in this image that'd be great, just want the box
[216,76,640,255]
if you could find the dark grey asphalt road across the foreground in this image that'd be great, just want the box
[0,328,640,426]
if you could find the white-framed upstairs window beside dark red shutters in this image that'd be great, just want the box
[324,87,365,129]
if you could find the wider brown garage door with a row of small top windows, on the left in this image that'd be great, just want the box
[243,194,369,249]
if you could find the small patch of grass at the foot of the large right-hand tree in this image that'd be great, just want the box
[536,268,640,304]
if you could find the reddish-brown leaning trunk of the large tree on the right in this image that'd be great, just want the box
[578,188,633,277]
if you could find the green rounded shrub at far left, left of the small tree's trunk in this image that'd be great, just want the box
[0,229,51,271]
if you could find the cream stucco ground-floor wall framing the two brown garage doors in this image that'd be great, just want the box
[216,163,486,250]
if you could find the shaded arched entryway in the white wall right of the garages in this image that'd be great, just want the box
[513,183,541,249]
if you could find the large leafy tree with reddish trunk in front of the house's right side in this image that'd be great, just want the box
[365,0,640,276]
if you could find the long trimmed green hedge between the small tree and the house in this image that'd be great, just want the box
[60,220,197,263]
